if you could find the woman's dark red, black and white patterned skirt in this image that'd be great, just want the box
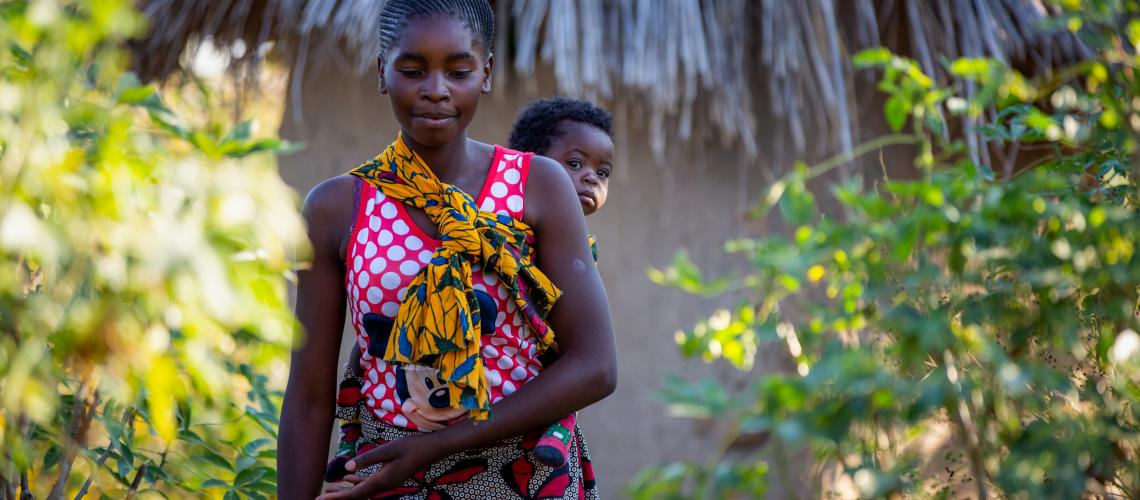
[336,367,597,500]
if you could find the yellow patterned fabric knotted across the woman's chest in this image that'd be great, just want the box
[349,136,562,420]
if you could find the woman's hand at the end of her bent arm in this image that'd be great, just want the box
[318,434,447,500]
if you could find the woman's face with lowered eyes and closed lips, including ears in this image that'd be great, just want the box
[380,15,492,148]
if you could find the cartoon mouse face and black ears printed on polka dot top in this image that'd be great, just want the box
[361,290,498,432]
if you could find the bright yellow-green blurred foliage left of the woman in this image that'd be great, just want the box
[0,0,303,498]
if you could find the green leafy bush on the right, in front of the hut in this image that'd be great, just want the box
[647,0,1140,499]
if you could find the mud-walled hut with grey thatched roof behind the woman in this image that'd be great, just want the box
[132,0,1086,498]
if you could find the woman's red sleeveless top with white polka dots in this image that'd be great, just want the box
[345,146,542,431]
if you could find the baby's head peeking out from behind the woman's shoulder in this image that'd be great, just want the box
[510,97,613,215]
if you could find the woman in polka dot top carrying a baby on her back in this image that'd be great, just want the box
[278,0,617,499]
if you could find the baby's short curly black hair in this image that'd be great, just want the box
[510,97,613,154]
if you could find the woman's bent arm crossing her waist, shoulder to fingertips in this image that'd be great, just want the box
[325,156,617,499]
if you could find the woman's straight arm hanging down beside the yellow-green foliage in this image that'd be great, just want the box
[277,177,353,500]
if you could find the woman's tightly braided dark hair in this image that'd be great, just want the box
[377,0,495,57]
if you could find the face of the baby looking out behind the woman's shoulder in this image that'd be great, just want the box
[544,121,613,215]
